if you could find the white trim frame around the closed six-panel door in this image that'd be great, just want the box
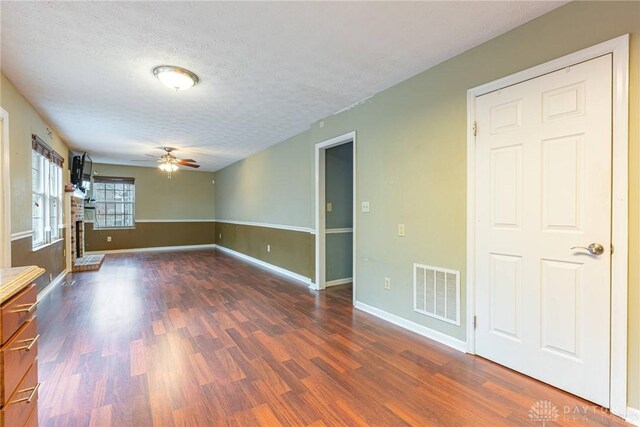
[467,34,629,418]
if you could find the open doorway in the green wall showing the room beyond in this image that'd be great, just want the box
[313,132,356,303]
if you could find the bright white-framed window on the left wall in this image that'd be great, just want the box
[31,135,64,249]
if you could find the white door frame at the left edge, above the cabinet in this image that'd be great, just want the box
[0,108,11,268]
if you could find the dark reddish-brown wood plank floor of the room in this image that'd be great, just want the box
[38,250,623,426]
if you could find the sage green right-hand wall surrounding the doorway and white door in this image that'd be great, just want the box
[216,2,640,408]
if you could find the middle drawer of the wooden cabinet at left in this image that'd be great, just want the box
[0,317,38,406]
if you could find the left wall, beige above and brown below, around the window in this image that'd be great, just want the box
[0,74,69,290]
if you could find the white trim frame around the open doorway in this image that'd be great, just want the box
[311,131,357,304]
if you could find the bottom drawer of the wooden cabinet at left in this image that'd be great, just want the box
[0,363,40,427]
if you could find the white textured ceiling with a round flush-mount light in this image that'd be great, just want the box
[0,1,563,171]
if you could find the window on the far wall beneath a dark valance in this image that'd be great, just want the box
[93,176,136,228]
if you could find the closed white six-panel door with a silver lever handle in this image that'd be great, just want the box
[475,55,612,407]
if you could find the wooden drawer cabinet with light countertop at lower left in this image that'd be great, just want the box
[0,267,44,427]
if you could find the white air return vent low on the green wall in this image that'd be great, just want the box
[413,264,460,326]
